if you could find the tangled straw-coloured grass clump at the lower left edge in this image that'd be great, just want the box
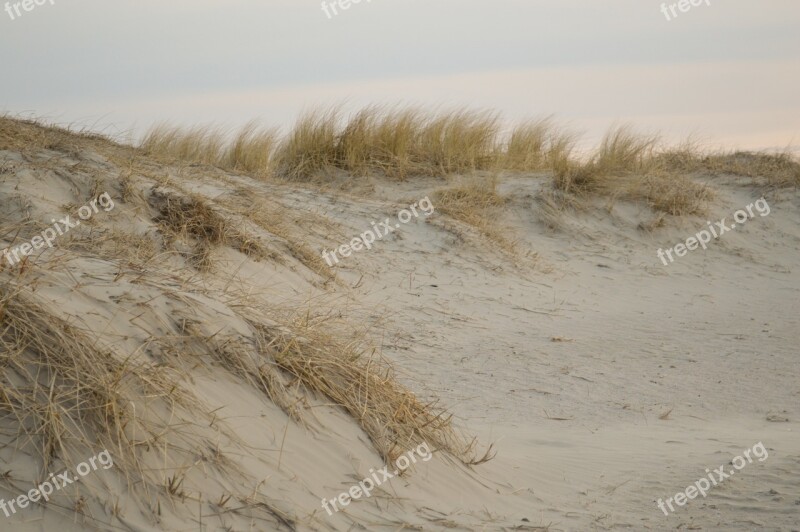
[0,279,205,511]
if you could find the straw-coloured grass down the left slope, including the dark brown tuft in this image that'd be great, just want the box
[0,125,491,529]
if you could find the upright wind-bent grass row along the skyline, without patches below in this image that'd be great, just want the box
[138,105,800,196]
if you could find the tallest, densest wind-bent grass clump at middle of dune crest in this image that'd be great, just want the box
[278,106,499,180]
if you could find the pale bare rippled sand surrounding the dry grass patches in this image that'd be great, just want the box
[0,118,800,531]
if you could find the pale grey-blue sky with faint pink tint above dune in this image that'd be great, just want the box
[0,0,800,149]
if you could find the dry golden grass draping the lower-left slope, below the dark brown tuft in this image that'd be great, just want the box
[0,262,482,530]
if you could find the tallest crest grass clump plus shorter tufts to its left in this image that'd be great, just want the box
[140,106,499,181]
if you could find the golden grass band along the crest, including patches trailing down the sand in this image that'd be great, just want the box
[140,105,800,250]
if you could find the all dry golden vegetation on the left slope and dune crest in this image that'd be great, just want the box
[0,110,800,530]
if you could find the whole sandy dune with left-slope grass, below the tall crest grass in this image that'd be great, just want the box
[0,119,800,530]
